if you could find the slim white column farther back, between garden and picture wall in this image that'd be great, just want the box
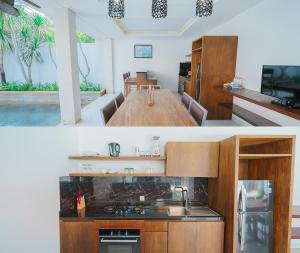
[104,39,115,93]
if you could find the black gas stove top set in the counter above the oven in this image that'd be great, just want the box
[103,205,149,216]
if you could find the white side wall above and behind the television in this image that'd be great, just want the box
[208,0,300,91]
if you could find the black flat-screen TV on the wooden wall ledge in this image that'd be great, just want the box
[261,65,300,103]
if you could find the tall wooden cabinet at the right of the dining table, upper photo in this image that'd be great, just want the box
[188,36,238,120]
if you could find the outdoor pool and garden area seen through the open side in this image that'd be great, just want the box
[0,5,105,126]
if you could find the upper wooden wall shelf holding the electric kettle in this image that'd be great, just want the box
[69,156,166,161]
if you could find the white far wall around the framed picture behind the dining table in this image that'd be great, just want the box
[113,39,192,91]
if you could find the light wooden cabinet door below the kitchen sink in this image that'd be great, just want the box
[168,222,224,253]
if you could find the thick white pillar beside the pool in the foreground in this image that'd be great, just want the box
[54,8,81,125]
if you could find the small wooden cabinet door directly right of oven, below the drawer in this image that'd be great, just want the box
[144,232,168,253]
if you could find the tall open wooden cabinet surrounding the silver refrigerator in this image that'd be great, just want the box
[208,136,295,253]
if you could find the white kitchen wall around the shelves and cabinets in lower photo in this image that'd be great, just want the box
[0,127,300,253]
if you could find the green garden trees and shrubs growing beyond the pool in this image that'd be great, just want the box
[0,5,102,92]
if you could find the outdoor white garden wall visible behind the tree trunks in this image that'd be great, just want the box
[4,40,105,87]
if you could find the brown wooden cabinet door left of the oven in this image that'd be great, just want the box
[60,221,99,253]
